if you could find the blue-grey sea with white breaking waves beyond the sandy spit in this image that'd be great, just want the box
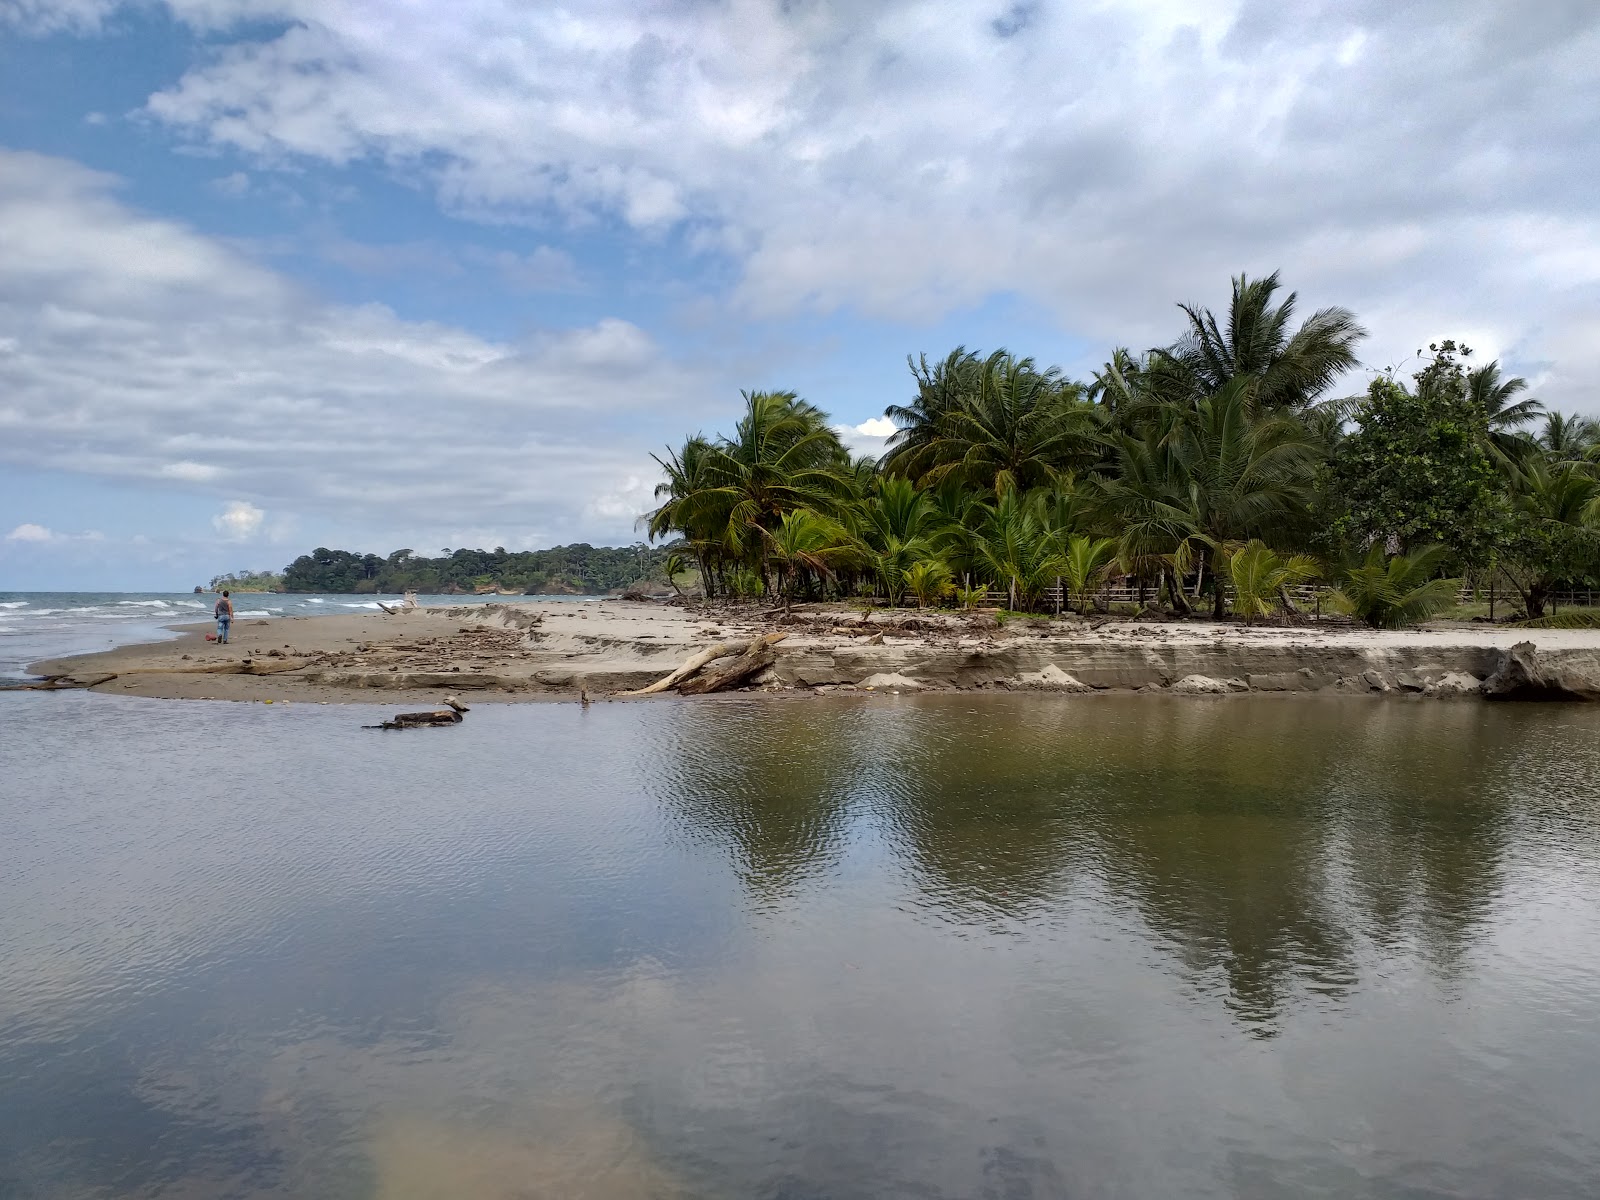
[0,592,598,678]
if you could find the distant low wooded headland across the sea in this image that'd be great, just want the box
[280,542,670,595]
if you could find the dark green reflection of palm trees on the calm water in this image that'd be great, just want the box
[661,698,1522,1032]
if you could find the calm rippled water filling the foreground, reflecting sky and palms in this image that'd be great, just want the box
[0,693,1600,1200]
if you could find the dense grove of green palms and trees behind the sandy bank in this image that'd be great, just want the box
[646,274,1600,624]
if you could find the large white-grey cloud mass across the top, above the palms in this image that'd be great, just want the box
[100,0,1600,400]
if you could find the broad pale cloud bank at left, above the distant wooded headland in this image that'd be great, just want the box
[0,150,734,546]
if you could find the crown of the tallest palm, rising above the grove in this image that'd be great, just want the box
[1166,272,1366,408]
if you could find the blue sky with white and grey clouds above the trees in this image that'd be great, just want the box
[0,0,1600,590]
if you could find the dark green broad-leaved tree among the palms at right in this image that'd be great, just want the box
[1334,355,1507,568]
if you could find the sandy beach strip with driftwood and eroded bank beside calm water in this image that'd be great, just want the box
[18,600,1600,704]
